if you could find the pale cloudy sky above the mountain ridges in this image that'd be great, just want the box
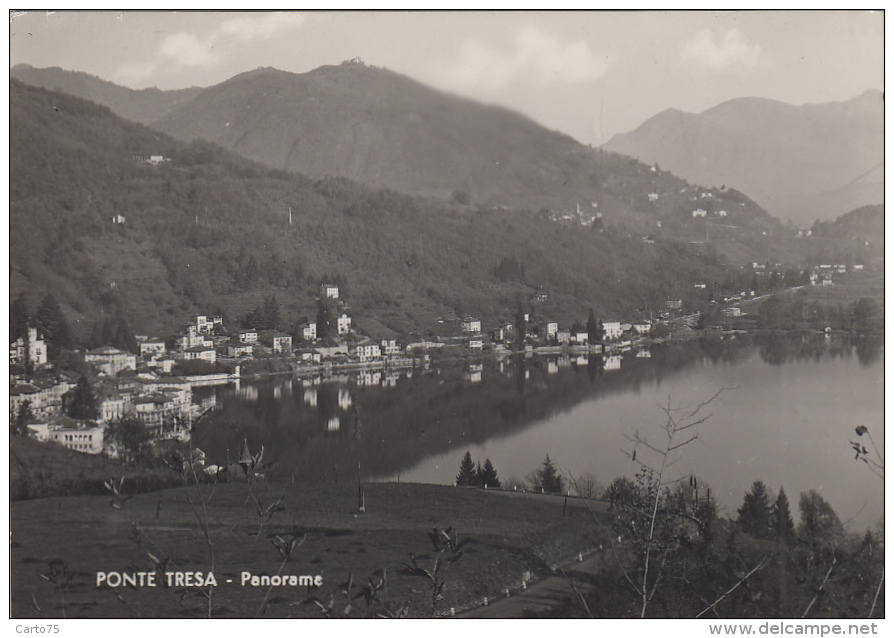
[9,11,884,146]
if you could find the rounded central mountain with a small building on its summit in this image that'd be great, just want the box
[8,62,787,263]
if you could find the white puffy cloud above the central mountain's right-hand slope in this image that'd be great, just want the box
[441,27,609,89]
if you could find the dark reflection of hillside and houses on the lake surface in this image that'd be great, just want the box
[195,335,883,528]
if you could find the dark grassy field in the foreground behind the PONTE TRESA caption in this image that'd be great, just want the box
[10,480,600,618]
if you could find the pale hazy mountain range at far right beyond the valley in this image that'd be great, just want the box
[603,91,884,226]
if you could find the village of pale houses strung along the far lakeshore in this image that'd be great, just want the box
[9,256,862,458]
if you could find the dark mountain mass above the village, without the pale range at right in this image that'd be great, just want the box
[10,63,880,337]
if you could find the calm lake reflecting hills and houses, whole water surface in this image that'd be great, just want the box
[194,335,884,530]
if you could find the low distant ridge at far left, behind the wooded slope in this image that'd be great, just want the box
[9,64,202,124]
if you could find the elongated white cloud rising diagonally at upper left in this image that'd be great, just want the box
[118,12,305,82]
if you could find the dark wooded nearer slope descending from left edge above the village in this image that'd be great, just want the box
[10,81,756,344]
